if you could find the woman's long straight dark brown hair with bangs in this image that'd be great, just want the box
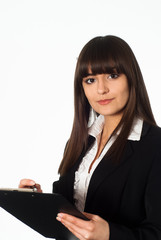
[59,35,156,175]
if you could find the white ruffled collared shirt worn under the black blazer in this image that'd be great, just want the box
[74,115,143,211]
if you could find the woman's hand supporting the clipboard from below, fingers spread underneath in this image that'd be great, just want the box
[57,213,110,240]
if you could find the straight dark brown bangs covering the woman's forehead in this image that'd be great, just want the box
[79,37,125,78]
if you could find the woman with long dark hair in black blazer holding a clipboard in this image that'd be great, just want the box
[20,36,161,240]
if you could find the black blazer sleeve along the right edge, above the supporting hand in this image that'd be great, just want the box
[109,150,161,240]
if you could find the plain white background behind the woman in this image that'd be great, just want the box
[0,0,161,240]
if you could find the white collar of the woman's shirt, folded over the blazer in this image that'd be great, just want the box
[88,115,143,141]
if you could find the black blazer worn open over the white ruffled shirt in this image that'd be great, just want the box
[53,123,161,240]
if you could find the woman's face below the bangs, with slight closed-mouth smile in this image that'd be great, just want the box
[82,73,129,120]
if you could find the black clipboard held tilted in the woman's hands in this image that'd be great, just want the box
[0,190,88,240]
